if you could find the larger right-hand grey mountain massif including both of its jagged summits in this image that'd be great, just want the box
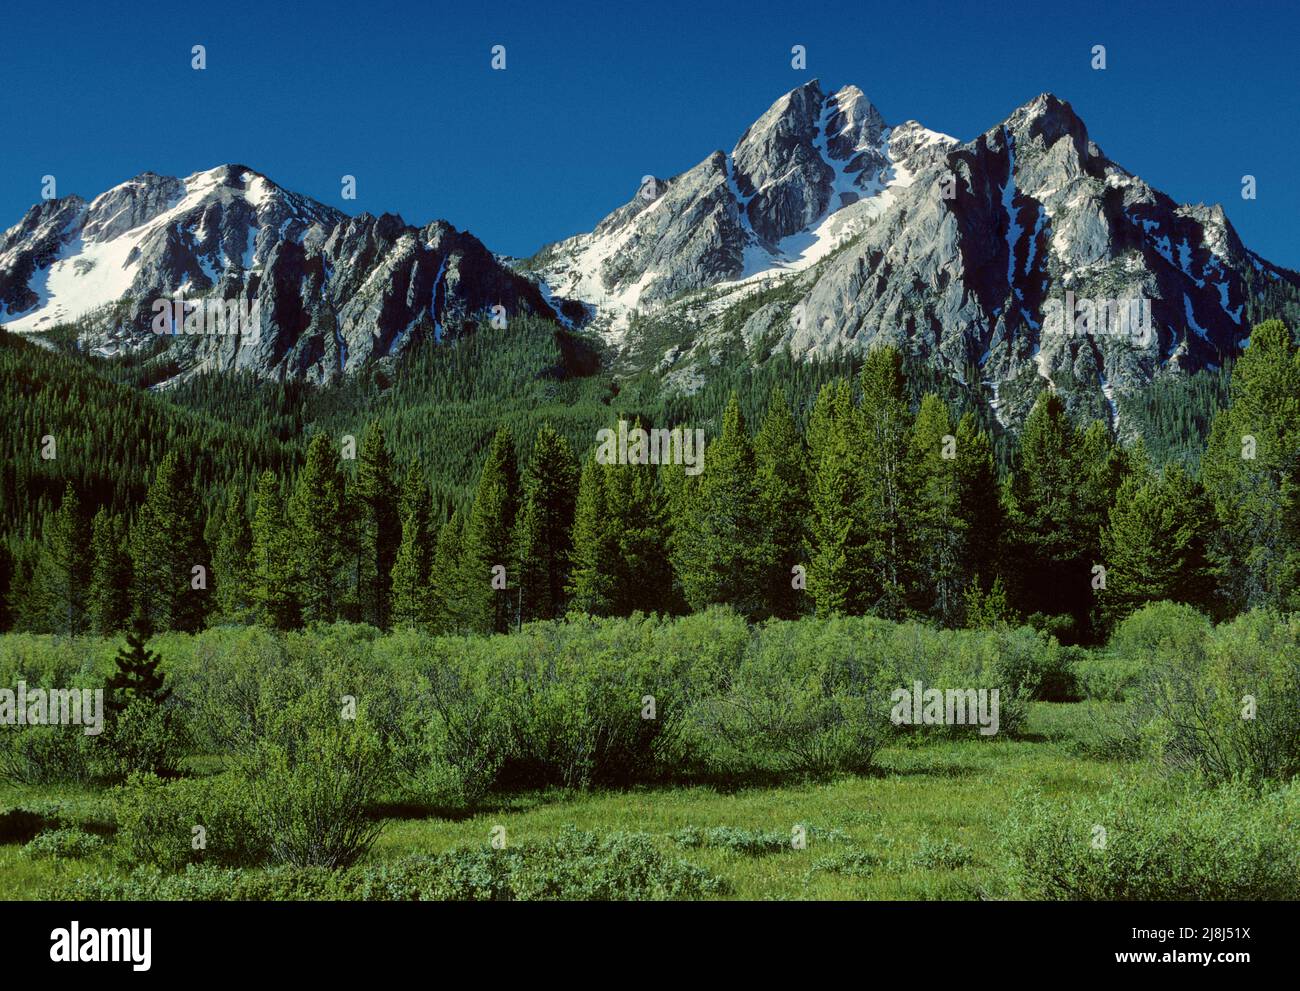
[523,81,1300,425]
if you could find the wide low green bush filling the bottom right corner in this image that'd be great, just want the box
[1005,786,1300,901]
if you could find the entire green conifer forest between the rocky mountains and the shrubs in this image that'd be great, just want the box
[0,312,1300,641]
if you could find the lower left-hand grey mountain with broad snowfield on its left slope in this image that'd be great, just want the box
[0,165,556,381]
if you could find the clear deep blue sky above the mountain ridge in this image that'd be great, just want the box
[0,0,1300,268]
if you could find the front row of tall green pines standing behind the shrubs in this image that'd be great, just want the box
[4,321,1300,642]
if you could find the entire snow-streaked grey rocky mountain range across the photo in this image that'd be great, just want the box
[0,81,1300,428]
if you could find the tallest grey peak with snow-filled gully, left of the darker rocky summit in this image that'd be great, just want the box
[523,81,957,336]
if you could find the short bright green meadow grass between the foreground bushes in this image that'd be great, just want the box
[0,702,1125,900]
